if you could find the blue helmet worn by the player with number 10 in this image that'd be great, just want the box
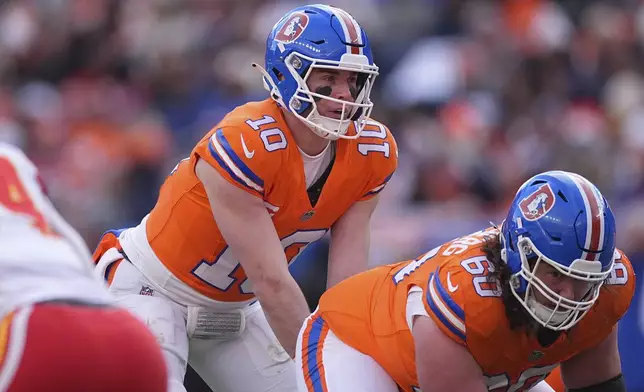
[254,4,378,140]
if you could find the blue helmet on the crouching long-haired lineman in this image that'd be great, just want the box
[501,171,615,330]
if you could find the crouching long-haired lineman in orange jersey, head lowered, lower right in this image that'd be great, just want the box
[296,171,635,392]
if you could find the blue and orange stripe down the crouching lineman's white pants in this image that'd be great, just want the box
[302,315,329,392]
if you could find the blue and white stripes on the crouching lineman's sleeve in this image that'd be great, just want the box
[426,270,466,344]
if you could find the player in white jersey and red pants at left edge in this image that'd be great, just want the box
[0,143,167,392]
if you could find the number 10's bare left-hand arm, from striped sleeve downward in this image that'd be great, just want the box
[196,161,310,356]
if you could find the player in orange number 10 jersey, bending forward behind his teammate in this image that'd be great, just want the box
[94,5,397,392]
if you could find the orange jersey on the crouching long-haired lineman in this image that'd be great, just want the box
[316,229,635,392]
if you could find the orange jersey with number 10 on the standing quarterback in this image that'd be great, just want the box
[138,99,397,302]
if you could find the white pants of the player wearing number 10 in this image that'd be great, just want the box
[109,260,297,392]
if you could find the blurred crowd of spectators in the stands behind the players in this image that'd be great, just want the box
[0,0,644,391]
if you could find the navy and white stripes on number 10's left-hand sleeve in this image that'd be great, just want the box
[208,129,264,195]
